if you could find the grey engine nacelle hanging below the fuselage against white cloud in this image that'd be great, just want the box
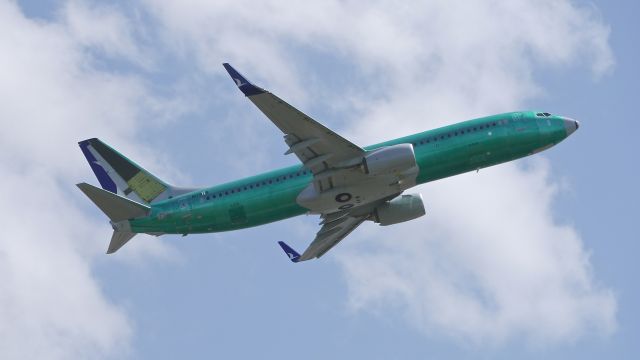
[373,194,427,226]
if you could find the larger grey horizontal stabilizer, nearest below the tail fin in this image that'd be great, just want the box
[76,183,151,222]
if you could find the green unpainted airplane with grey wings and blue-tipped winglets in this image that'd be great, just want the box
[77,63,579,263]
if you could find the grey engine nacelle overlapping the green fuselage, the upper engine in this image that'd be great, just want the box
[362,144,417,176]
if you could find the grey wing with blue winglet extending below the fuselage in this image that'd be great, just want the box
[279,212,369,262]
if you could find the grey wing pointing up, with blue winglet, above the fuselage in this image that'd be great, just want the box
[223,63,365,174]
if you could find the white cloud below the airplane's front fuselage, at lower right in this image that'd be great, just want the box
[337,159,616,345]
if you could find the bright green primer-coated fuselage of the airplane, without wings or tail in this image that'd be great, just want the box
[130,112,568,234]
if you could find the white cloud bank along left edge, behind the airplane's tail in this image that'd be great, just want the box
[0,2,175,359]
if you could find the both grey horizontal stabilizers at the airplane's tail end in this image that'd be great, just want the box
[77,183,151,254]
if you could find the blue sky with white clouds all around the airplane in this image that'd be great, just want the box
[0,1,640,359]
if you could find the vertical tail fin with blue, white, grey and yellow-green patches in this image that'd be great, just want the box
[78,138,196,204]
